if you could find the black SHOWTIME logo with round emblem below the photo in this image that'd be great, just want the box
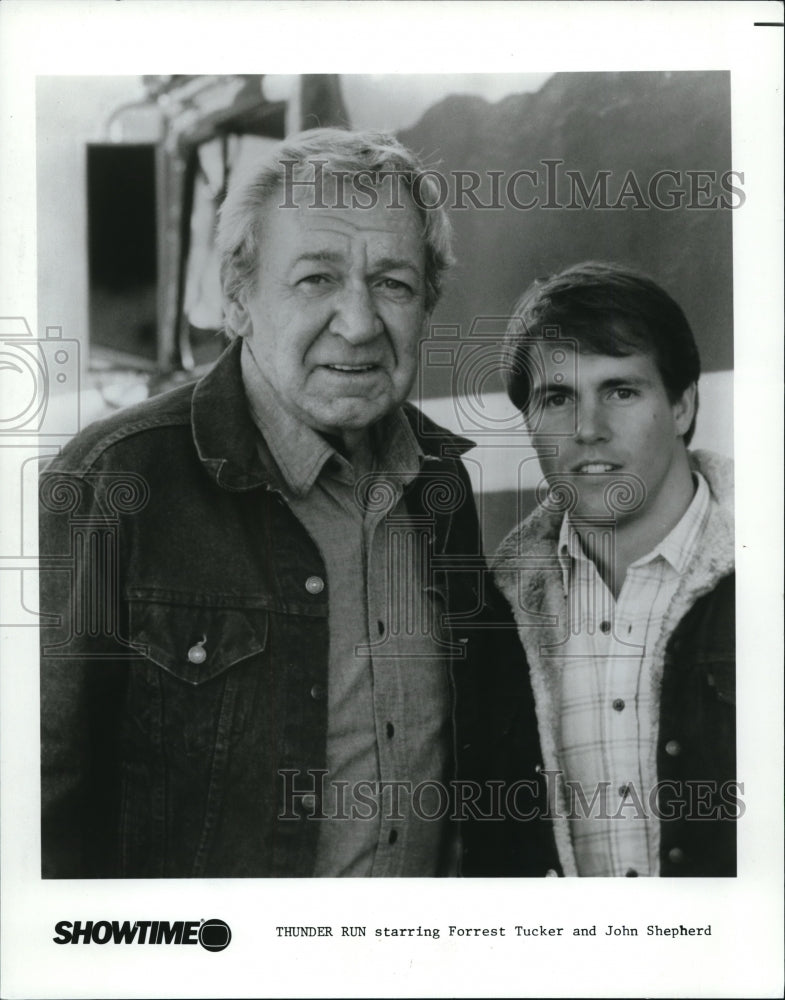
[52,919,232,951]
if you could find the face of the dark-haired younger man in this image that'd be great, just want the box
[531,345,694,534]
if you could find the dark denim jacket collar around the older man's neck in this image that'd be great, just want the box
[191,339,474,491]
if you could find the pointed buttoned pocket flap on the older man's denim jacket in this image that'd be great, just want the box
[129,600,268,684]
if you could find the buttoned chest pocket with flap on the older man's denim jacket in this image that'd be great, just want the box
[128,598,269,757]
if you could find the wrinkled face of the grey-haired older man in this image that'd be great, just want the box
[236,182,428,451]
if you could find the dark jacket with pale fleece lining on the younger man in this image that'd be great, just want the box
[493,452,744,876]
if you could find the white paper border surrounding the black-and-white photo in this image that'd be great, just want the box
[0,0,783,998]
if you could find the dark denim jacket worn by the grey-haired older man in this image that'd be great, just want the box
[40,344,556,878]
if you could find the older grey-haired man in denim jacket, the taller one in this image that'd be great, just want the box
[36,130,552,877]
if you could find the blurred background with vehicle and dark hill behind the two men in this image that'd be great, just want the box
[37,72,732,549]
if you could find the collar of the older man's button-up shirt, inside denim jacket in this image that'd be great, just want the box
[240,343,425,497]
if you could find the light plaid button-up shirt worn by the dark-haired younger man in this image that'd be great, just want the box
[557,473,709,876]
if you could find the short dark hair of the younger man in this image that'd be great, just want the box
[504,261,700,444]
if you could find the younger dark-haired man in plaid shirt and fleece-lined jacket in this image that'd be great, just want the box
[495,263,744,877]
